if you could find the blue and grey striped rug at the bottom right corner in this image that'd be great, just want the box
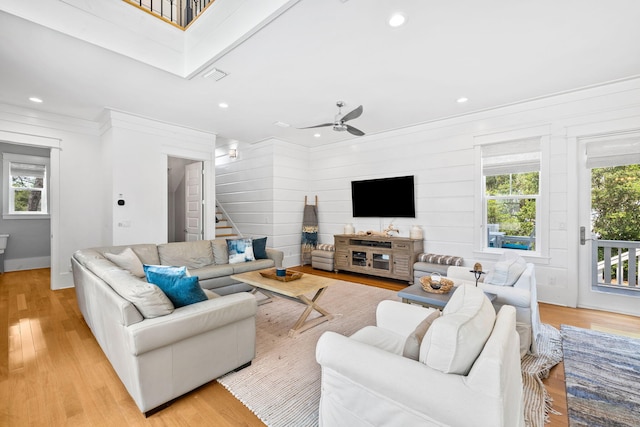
[560,325,640,427]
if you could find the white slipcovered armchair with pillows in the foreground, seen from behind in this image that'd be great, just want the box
[316,287,524,427]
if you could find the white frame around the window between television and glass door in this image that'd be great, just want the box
[474,125,550,263]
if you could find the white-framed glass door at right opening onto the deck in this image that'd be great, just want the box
[577,132,640,315]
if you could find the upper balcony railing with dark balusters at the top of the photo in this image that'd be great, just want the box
[123,0,214,29]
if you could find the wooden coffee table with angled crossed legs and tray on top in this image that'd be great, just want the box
[231,270,338,336]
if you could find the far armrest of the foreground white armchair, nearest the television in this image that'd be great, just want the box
[376,300,436,337]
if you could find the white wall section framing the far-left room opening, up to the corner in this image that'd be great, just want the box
[0,105,103,289]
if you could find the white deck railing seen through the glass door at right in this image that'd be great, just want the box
[592,240,640,290]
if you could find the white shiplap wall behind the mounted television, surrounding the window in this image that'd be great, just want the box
[218,79,640,306]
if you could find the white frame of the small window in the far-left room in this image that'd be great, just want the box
[2,153,50,219]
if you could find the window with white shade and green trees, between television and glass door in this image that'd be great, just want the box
[482,138,540,251]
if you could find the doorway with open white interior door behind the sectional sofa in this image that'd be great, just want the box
[167,157,204,242]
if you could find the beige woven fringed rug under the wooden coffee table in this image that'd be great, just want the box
[218,281,561,427]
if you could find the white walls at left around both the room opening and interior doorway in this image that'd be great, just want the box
[0,105,215,289]
